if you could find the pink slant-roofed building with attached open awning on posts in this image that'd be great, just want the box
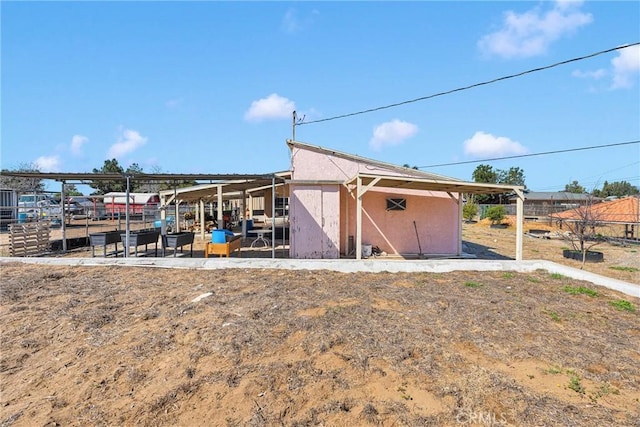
[287,140,522,259]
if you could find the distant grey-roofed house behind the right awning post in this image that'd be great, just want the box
[509,191,602,217]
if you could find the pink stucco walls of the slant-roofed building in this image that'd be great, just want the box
[290,147,460,258]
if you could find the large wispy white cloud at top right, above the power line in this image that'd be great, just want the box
[478,0,593,58]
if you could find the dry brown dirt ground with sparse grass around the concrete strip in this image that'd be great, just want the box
[0,224,640,427]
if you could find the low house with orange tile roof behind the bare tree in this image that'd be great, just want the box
[550,196,640,240]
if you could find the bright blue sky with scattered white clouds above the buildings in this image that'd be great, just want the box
[0,1,640,195]
